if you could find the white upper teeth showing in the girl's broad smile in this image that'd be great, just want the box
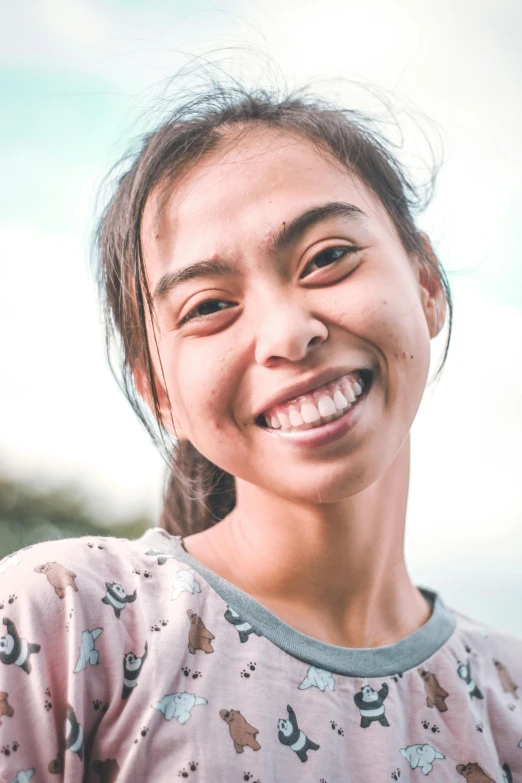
[264,373,364,429]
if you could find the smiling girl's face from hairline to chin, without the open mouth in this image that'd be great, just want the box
[135,130,445,504]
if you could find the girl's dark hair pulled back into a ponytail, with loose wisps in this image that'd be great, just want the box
[95,67,453,535]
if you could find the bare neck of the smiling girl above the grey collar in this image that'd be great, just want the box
[184,437,431,647]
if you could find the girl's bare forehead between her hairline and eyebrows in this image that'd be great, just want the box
[142,129,391,277]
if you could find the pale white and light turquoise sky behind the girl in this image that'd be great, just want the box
[0,0,522,633]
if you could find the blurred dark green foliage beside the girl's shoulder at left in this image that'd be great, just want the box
[0,476,154,558]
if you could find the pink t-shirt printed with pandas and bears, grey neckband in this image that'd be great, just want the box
[0,528,522,783]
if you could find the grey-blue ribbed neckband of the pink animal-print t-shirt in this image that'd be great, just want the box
[137,527,457,677]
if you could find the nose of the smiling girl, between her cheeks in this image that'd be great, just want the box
[252,292,328,365]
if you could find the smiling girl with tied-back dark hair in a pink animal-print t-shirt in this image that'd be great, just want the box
[0,81,522,783]
